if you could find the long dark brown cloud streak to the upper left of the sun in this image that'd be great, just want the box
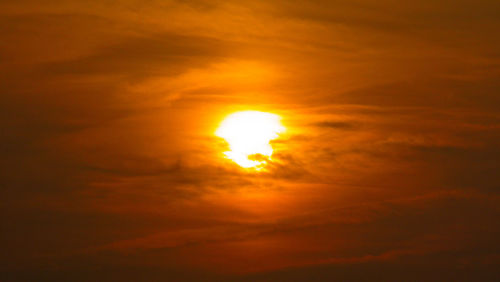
[41,34,229,79]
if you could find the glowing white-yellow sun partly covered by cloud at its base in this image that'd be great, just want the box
[215,111,285,169]
